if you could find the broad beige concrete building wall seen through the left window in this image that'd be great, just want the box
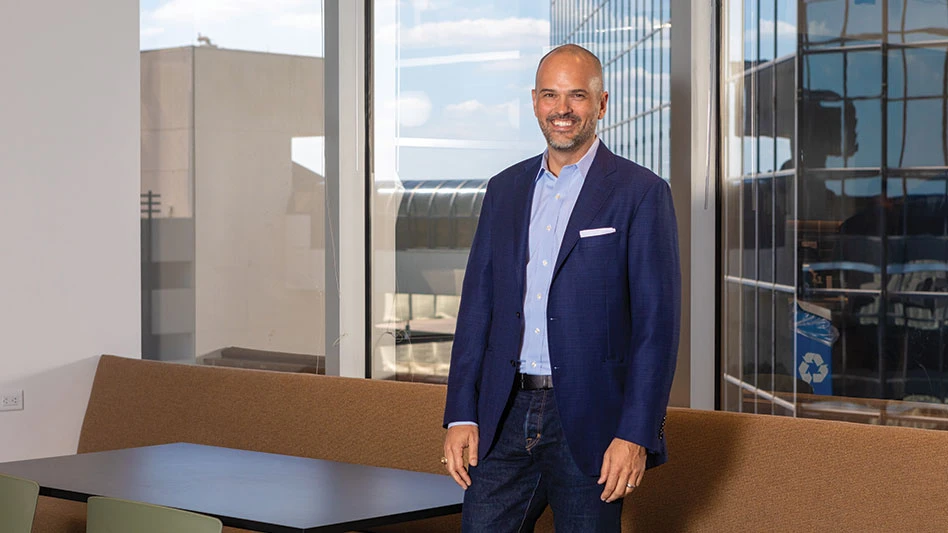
[194,47,328,355]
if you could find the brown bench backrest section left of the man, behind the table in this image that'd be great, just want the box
[79,355,445,473]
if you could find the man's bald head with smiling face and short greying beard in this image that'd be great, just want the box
[533,47,609,156]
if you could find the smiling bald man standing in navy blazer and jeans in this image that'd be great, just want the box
[442,45,680,533]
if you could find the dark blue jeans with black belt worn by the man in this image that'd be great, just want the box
[461,390,622,533]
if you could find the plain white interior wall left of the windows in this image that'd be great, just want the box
[0,0,141,461]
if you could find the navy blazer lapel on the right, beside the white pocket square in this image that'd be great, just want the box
[553,140,616,279]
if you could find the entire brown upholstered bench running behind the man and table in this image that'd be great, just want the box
[33,356,948,533]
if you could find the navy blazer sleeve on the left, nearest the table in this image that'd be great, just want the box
[443,182,493,427]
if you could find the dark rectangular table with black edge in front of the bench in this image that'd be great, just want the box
[0,443,464,533]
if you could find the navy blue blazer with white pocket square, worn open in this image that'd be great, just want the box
[444,143,681,476]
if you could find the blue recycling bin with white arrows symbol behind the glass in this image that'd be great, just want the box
[795,302,839,395]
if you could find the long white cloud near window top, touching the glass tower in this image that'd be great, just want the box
[399,17,550,49]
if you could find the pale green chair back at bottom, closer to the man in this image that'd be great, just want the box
[86,496,223,533]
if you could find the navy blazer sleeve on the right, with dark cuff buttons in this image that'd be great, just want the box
[616,181,681,452]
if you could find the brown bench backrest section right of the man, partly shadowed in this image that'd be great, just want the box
[625,409,948,532]
